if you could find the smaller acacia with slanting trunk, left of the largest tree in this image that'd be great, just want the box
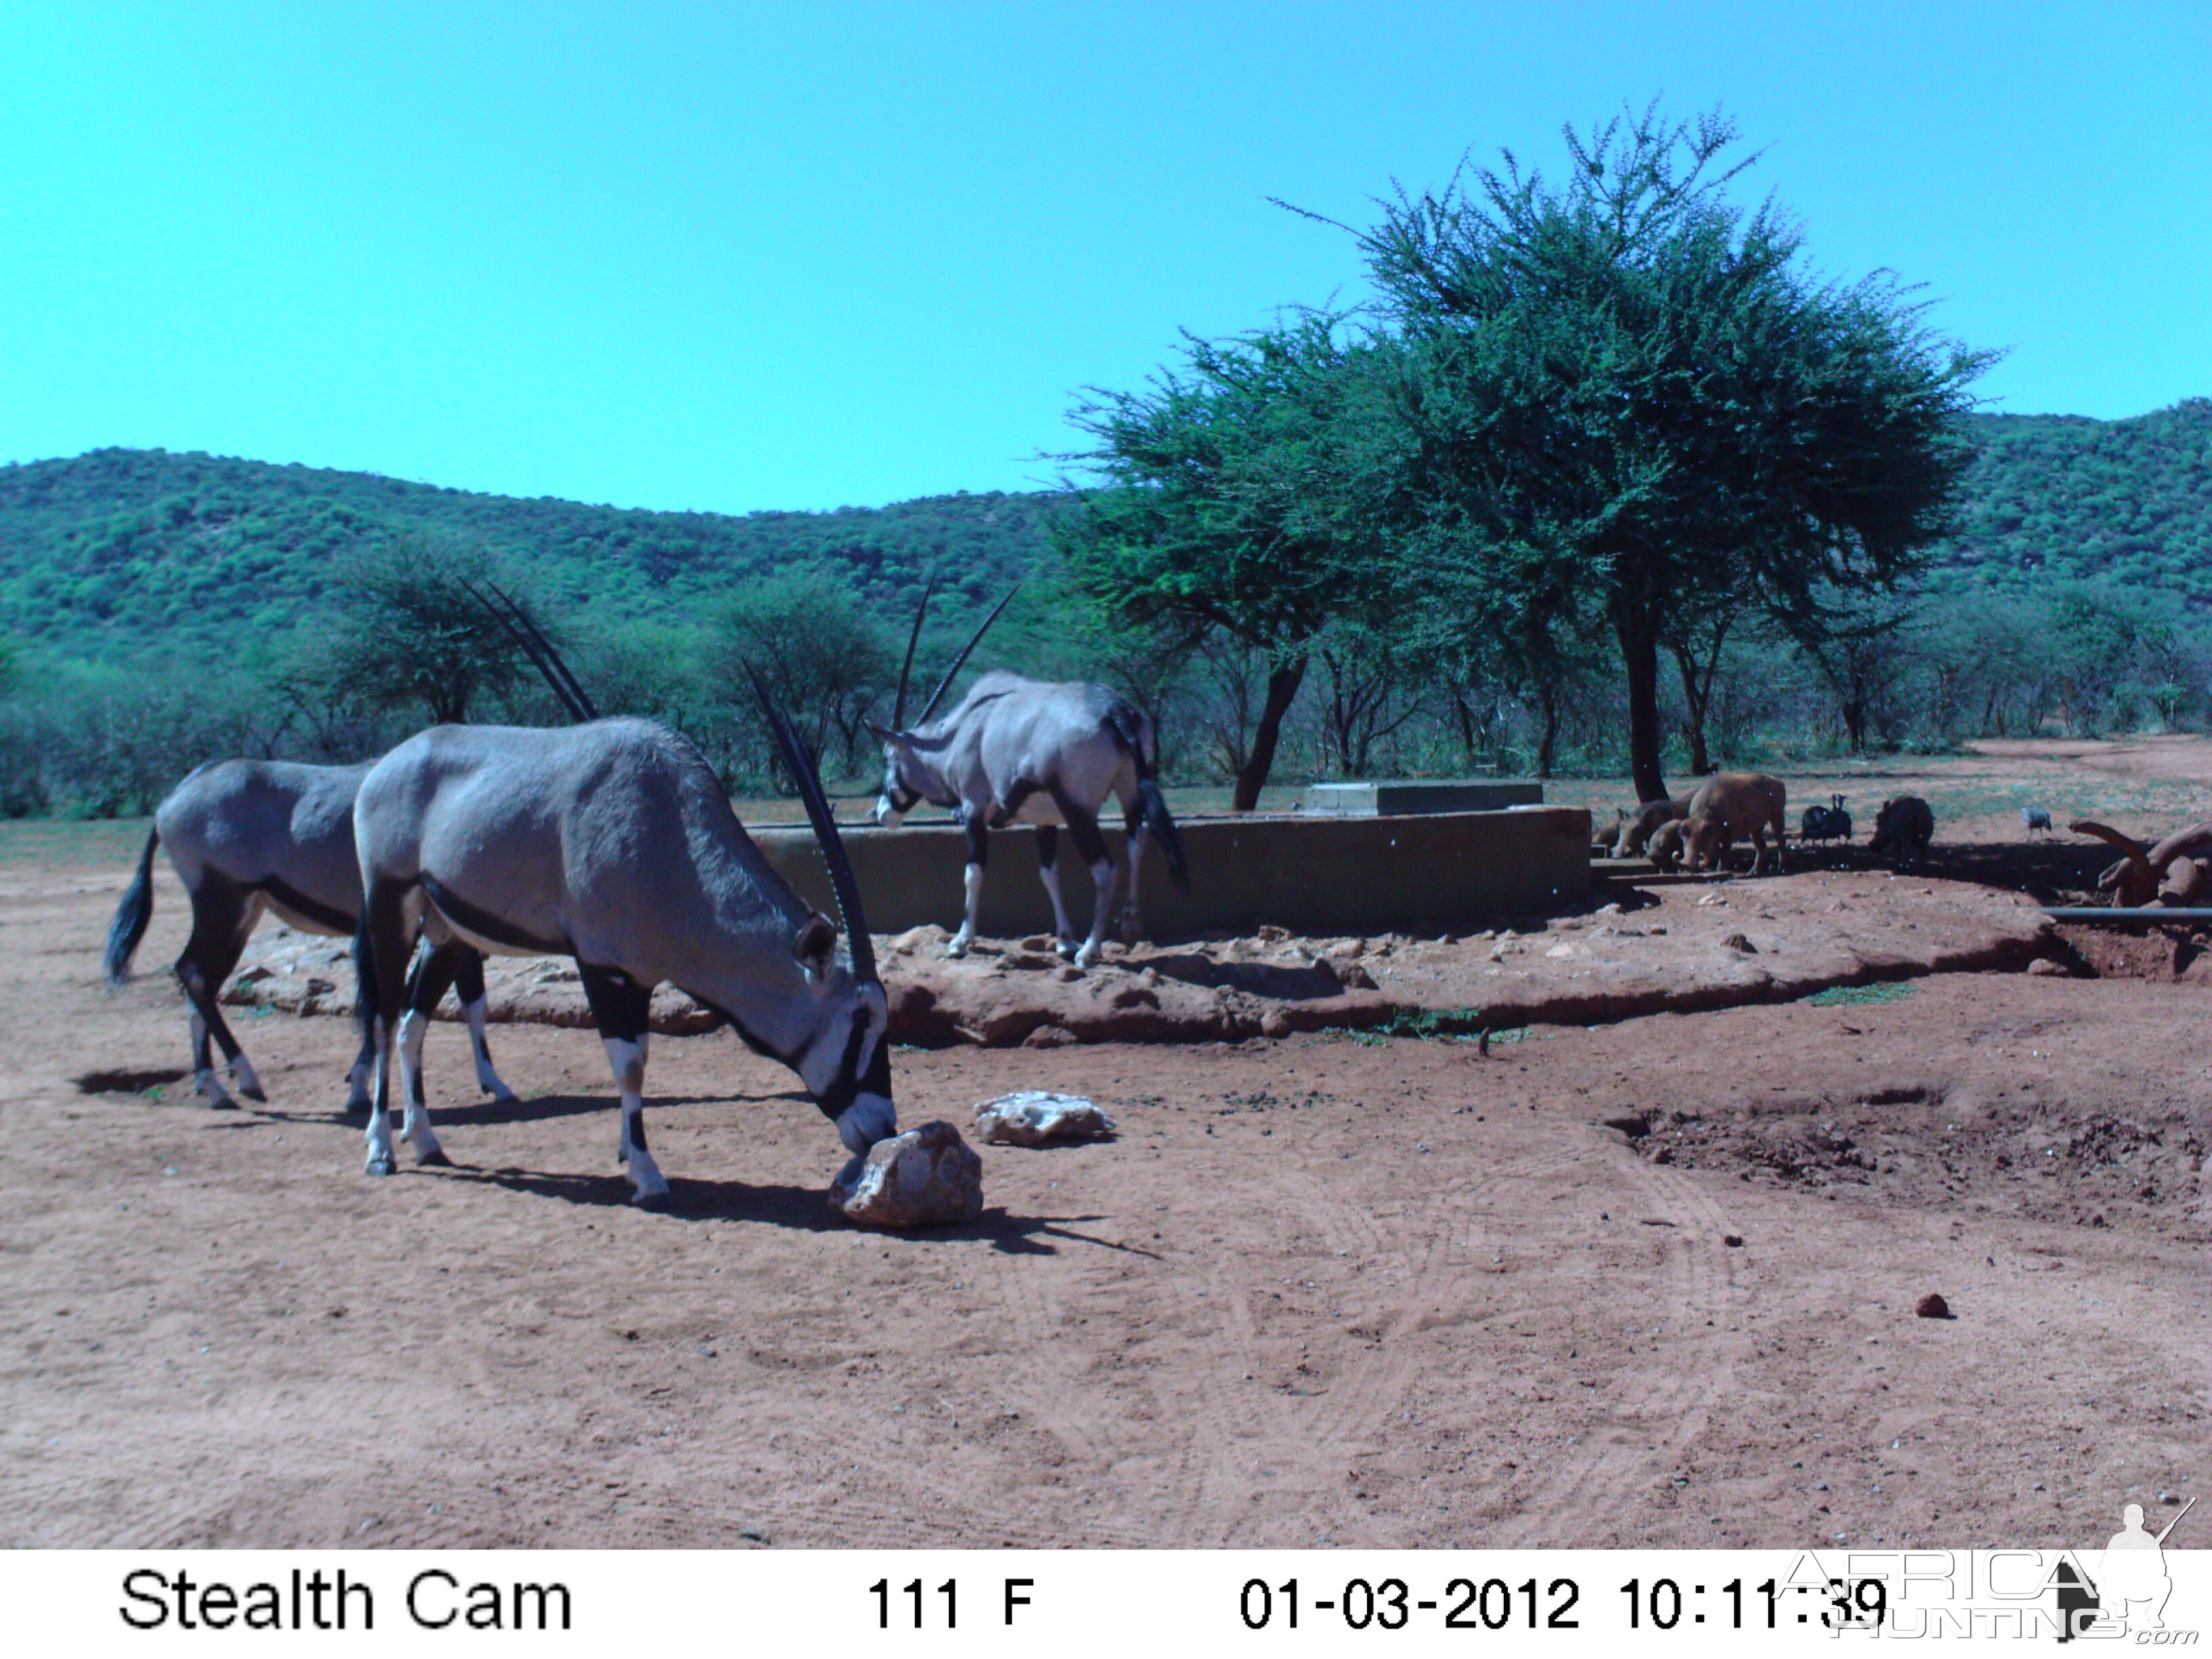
[1055,314,1385,812]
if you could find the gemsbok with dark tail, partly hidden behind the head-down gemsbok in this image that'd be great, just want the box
[106,761,513,1111]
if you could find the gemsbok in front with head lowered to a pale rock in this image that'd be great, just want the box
[354,679,898,1208]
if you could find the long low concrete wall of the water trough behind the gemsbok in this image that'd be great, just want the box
[752,807,1591,938]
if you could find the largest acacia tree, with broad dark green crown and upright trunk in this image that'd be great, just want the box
[1354,104,1991,798]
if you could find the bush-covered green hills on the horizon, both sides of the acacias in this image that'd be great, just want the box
[0,398,2212,661]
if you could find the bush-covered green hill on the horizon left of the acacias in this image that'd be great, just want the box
[0,449,1055,661]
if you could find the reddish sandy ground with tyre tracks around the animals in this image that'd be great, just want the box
[0,741,2212,1547]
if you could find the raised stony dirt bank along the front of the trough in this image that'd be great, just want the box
[226,869,2051,1048]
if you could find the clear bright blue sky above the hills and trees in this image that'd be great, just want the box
[0,0,2212,513]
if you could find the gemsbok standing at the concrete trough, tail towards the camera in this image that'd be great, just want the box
[869,581,1190,966]
